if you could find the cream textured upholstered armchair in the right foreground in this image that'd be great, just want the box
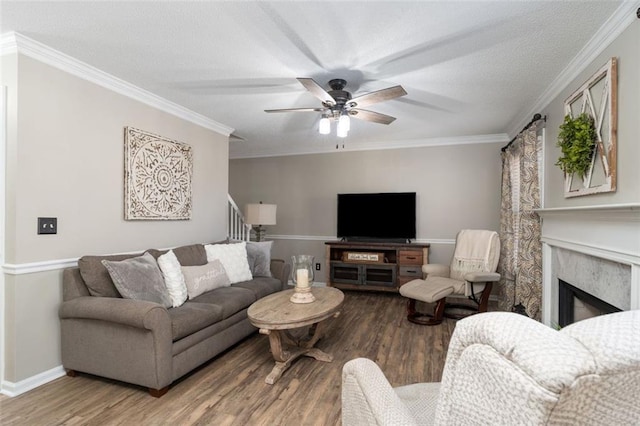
[342,310,640,426]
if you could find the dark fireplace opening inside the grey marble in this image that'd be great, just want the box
[558,279,621,327]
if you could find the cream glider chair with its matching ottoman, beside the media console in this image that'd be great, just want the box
[400,229,500,325]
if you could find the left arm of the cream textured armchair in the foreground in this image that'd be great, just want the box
[342,358,416,426]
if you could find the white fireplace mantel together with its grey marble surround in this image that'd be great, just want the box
[536,204,640,325]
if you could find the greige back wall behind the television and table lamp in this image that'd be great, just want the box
[229,143,502,282]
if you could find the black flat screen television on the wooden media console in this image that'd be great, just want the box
[338,192,416,241]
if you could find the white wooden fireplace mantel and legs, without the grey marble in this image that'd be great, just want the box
[536,203,640,325]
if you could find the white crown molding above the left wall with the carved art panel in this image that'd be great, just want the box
[0,32,234,136]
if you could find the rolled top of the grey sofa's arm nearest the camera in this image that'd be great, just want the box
[58,296,171,330]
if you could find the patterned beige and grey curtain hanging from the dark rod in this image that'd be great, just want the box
[498,122,542,320]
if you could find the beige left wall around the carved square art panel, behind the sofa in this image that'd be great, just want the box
[0,54,228,387]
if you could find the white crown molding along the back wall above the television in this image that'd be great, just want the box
[229,133,509,160]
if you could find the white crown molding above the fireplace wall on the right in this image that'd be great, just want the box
[509,0,640,136]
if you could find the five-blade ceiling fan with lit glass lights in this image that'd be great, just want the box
[264,78,407,137]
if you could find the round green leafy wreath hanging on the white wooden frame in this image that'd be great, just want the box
[556,112,598,179]
